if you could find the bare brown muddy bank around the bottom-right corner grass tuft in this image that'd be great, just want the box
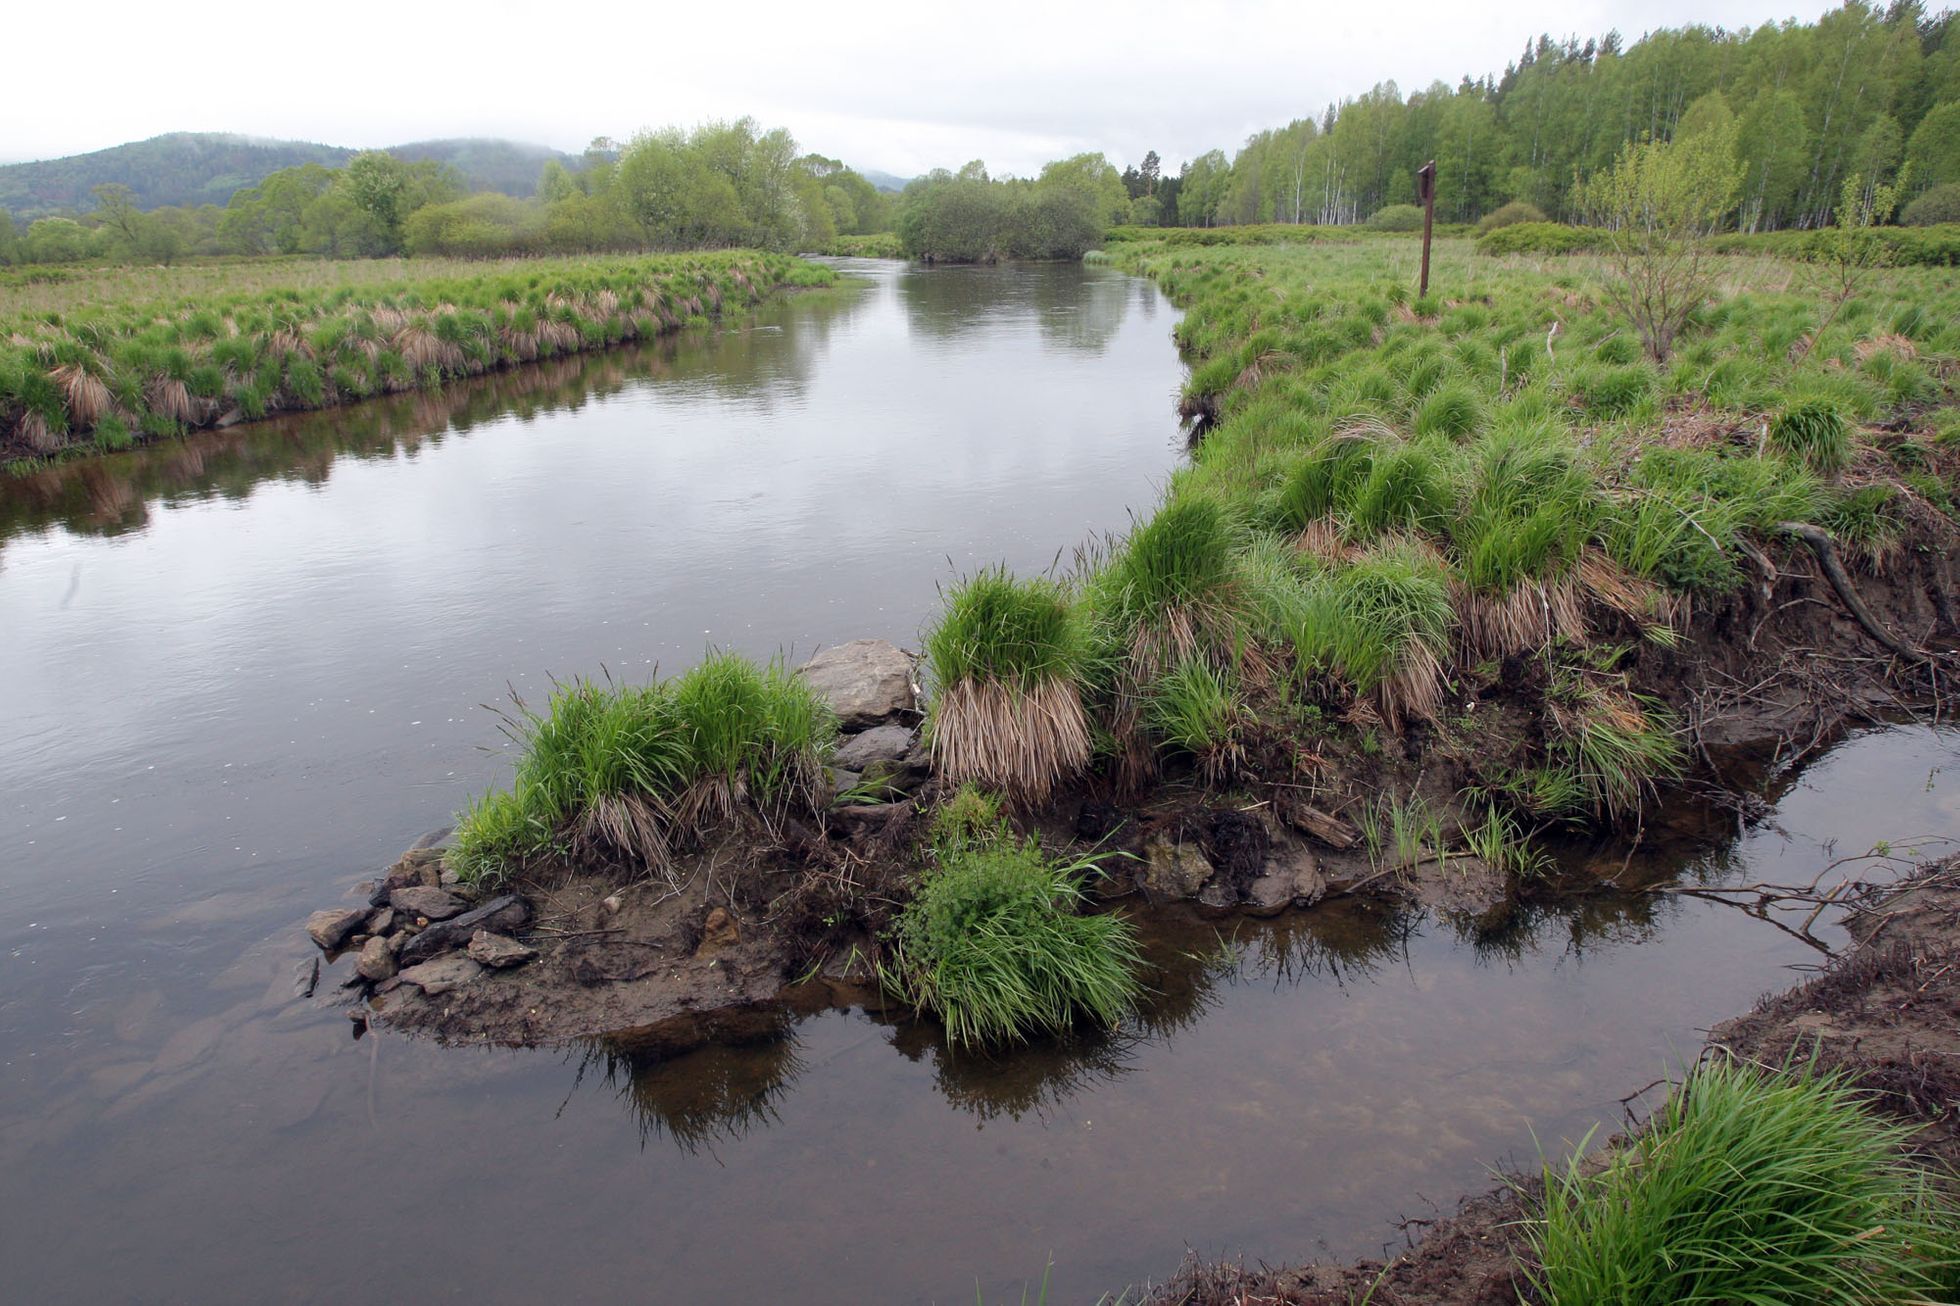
[1141,859,1960,1306]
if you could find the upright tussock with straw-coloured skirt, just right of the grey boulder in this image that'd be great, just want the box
[925,567,1090,802]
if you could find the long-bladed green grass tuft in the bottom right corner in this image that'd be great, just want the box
[1529,1059,1952,1306]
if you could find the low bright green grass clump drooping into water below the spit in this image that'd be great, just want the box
[880,841,1143,1045]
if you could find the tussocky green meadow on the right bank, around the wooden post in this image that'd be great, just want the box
[927,229,1960,865]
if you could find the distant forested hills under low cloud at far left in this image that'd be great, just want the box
[0,131,574,218]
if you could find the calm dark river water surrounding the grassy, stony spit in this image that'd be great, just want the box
[0,256,1960,1302]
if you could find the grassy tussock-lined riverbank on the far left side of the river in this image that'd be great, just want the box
[0,251,837,471]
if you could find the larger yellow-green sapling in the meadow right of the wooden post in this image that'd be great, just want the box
[1580,116,1740,363]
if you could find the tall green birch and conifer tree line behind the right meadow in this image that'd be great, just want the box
[1133,0,1960,231]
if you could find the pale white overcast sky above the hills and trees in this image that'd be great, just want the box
[0,0,1833,176]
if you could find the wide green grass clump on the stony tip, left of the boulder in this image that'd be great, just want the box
[449,653,837,884]
